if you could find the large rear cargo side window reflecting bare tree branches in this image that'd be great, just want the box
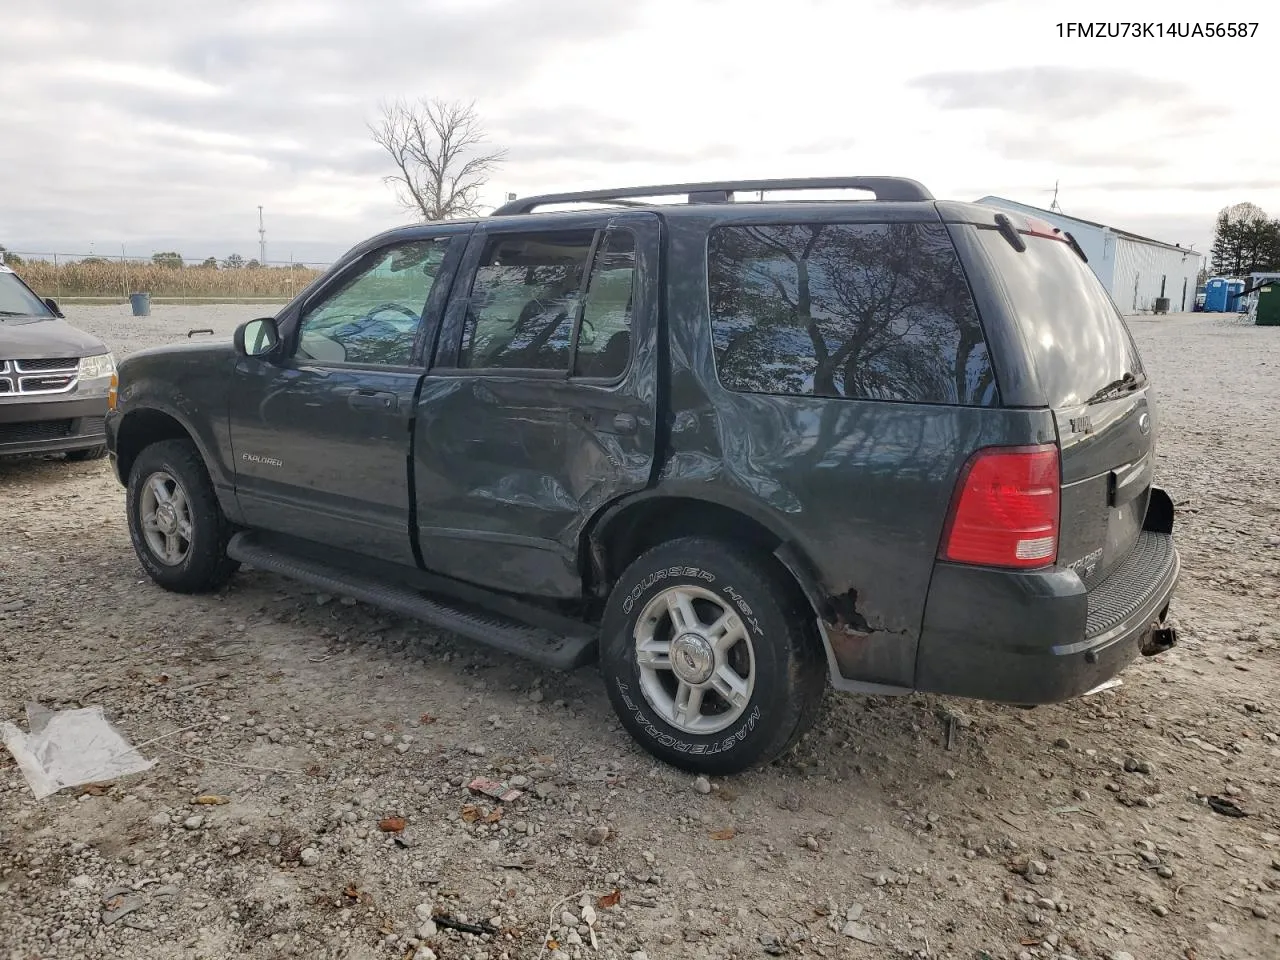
[708,224,996,406]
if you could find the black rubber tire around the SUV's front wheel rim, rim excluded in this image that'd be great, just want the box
[127,440,239,594]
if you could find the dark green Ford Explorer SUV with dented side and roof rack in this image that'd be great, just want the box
[108,178,1179,773]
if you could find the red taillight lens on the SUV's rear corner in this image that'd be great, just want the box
[941,444,1060,568]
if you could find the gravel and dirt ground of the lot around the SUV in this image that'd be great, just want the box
[0,306,1280,960]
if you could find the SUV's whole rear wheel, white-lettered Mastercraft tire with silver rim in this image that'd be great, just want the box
[600,538,827,774]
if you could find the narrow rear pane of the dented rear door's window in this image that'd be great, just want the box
[573,230,636,380]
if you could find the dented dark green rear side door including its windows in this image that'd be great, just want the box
[413,211,660,596]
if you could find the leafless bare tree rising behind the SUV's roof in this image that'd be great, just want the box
[369,100,507,220]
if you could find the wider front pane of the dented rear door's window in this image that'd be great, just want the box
[458,230,595,371]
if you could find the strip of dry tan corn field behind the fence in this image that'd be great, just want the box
[9,255,324,301]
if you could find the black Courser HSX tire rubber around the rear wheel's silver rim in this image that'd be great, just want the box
[600,538,827,776]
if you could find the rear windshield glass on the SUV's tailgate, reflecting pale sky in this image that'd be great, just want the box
[978,229,1146,407]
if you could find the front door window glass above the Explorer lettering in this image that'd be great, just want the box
[297,239,448,365]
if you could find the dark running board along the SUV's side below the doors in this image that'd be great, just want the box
[227,532,596,671]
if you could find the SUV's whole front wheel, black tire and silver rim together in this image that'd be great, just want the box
[127,440,239,593]
